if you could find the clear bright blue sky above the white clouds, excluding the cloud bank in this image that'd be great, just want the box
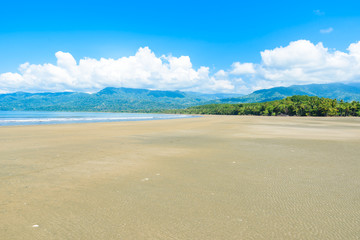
[0,0,360,91]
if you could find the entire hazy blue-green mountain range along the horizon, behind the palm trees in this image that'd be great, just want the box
[0,83,360,112]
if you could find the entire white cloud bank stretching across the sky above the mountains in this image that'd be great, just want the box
[0,40,360,93]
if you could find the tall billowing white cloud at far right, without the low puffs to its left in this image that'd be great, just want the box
[257,40,360,85]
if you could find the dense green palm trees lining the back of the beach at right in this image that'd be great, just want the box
[166,95,360,116]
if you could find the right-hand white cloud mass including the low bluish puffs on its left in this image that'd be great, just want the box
[225,40,360,92]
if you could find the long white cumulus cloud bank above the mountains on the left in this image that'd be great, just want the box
[0,47,234,92]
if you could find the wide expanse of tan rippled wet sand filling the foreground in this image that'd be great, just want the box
[0,116,360,240]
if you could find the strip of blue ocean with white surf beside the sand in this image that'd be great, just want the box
[0,111,194,126]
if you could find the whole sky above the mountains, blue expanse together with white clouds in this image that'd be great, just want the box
[0,0,360,94]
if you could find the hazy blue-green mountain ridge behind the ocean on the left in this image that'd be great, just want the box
[0,87,241,111]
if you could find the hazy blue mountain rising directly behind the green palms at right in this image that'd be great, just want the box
[211,83,360,103]
